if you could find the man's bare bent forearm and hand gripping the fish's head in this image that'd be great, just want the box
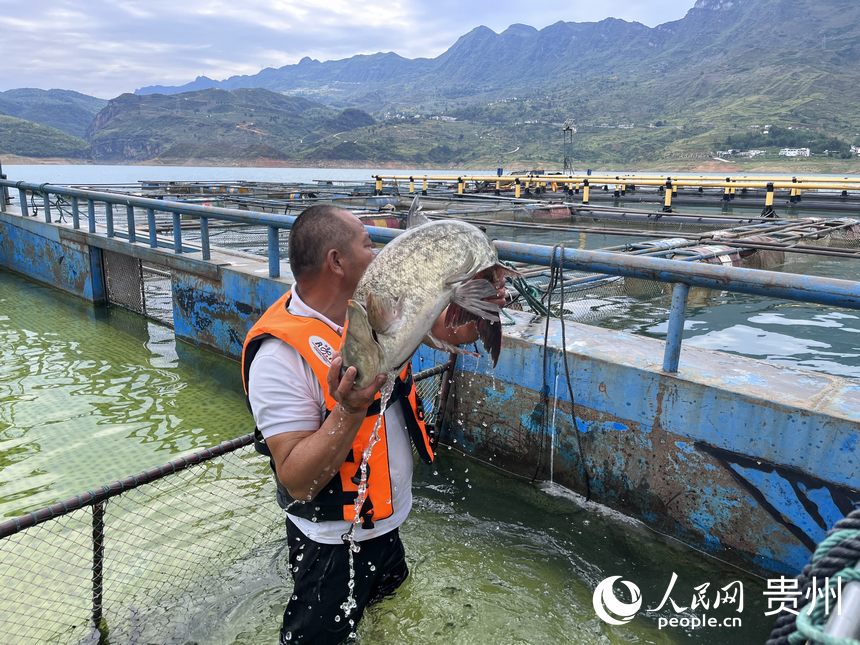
[266,355,385,501]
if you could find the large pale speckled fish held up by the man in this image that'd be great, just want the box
[341,197,516,388]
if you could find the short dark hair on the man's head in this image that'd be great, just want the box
[289,204,352,279]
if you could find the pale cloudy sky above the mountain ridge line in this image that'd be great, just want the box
[0,0,694,98]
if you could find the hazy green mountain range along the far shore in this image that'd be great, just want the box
[0,0,860,165]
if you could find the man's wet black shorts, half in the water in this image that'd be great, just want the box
[281,518,409,645]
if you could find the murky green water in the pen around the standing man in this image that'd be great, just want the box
[0,271,772,644]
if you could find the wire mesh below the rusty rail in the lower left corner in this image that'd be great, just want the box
[0,446,284,643]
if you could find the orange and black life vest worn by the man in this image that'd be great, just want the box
[242,291,433,528]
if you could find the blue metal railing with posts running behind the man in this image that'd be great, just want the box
[5,179,860,373]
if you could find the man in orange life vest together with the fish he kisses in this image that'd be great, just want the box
[242,199,509,643]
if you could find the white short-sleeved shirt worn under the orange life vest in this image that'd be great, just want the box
[248,288,412,544]
